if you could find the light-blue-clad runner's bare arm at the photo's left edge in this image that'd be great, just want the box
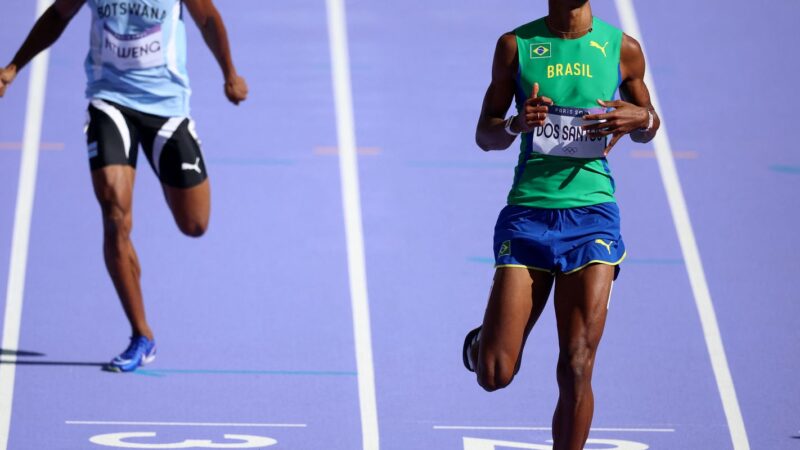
[0,0,86,97]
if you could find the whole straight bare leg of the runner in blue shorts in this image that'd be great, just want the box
[553,264,614,450]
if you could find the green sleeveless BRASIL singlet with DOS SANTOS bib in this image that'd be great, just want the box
[508,18,622,208]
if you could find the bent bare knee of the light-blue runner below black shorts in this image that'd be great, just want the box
[163,178,211,237]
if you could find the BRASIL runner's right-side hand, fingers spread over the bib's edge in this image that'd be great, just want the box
[583,100,650,155]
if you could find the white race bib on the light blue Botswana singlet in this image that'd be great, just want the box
[103,25,166,70]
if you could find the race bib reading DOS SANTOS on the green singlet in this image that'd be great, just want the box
[531,105,606,158]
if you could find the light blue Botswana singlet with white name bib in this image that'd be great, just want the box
[85,0,191,116]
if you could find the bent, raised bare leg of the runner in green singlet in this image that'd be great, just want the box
[476,267,553,392]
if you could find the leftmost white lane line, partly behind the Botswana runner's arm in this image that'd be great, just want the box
[0,0,52,448]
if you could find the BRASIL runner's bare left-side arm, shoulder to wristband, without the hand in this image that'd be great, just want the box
[475,33,520,151]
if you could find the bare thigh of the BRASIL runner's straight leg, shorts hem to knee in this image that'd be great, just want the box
[554,264,615,356]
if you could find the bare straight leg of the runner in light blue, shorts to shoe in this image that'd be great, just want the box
[92,165,153,339]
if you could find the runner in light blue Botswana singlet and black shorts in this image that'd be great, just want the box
[0,0,247,372]
